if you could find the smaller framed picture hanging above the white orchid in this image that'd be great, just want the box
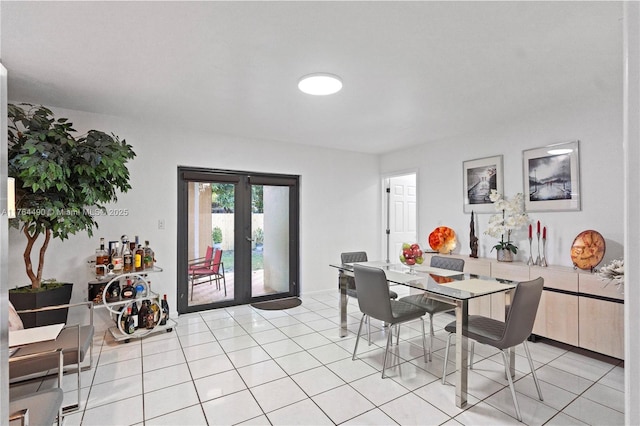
[462,155,503,213]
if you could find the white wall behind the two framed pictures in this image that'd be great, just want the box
[381,92,623,266]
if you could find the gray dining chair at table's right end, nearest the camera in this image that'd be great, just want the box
[442,277,544,421]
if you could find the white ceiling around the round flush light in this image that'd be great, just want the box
[0,1,622,153]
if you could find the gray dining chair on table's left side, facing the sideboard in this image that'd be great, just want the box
[351,265,427,379]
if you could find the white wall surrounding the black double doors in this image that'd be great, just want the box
[9,109,380,320]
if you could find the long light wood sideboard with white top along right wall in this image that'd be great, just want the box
[425,254,624,359]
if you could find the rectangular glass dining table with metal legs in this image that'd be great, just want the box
[330,261,517,408]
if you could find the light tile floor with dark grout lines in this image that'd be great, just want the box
[13,293,624,425]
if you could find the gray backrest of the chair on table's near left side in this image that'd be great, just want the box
[353,265,393,323]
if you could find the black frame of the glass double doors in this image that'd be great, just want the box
[176,166,300,314]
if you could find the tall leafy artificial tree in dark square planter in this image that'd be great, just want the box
[7,104,135,327]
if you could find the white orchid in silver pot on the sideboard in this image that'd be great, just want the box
[484,190,529,262]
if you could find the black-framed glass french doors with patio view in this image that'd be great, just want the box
[177,167,299,313]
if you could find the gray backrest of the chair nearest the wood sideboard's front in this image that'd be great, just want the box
[497,277,544,349]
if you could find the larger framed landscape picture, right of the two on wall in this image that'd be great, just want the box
[522,141,580,212]
